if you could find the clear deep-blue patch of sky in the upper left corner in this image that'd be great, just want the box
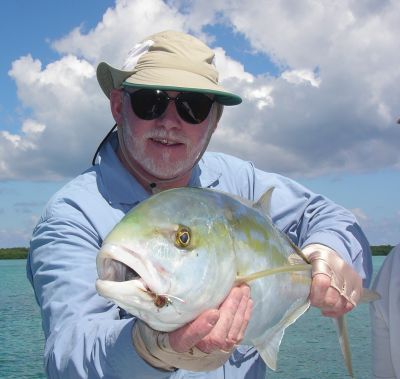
[0,0,109,121]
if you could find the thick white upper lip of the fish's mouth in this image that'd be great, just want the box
[96,243,169,297]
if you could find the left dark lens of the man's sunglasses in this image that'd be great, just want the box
[129,89,168,120]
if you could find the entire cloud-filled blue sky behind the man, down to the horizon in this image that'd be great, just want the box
[0,0,400,247]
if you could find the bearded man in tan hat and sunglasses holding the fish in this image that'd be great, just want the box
[28,31,371,378]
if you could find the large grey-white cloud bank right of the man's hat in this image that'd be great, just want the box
[206,1,400,176]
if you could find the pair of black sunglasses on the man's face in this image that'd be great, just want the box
[127,89,214,124]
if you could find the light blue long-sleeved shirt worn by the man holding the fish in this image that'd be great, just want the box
[27,135,372,379]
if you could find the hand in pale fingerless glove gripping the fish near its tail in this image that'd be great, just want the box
[303,245,362,318]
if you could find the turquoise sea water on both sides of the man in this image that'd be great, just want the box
[0,257,384,379]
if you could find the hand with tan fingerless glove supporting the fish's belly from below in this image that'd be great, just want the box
[133,285,253,371]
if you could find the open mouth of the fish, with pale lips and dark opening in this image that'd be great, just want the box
[96,243,166,303]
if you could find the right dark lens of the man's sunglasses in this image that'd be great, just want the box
[175,92,213,124]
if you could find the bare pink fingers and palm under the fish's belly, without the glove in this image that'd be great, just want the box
[169,285,253,353]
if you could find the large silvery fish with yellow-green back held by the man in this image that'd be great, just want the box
[96,188,351,370]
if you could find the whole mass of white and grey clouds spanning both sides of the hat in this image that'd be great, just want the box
[0,0,400,179]
